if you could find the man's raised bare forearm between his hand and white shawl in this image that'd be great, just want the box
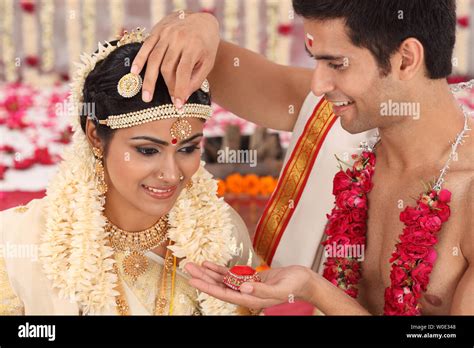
[209,41,312,131]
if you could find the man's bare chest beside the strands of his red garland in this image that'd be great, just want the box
[359,169,465,314]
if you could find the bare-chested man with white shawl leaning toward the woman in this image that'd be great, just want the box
[132,0,474,315]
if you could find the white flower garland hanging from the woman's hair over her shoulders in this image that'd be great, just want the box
[40,34,241,315]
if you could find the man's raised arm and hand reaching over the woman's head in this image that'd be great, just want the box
[132,12,312,131]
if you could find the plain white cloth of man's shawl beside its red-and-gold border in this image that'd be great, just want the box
[272,93,377,271]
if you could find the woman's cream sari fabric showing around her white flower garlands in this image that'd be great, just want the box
[0,197,258,315]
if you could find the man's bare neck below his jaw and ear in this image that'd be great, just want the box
[377,81,464,171]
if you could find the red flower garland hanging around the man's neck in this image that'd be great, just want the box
[323,151,451,315]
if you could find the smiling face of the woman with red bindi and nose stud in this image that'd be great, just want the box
[105,118,204,220]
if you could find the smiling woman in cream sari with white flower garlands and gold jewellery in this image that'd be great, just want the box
[0,29,257,315]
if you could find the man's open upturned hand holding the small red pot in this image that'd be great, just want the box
[185,262,317,309]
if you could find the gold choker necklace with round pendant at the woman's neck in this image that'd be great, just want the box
[105,215,169,281]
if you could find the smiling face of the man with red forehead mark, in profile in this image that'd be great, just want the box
[304,19,399,134]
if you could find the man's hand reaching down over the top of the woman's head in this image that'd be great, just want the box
[131,11,220,108]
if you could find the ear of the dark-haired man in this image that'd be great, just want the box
[392,38,426,81]
